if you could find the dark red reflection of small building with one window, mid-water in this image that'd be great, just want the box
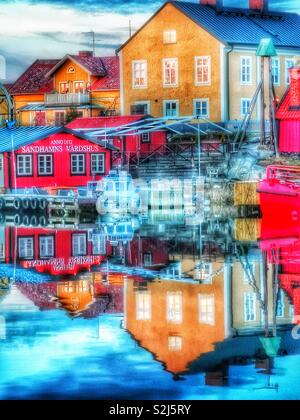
[127,238,169,269]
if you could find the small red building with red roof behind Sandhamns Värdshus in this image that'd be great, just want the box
[68,115,167,159]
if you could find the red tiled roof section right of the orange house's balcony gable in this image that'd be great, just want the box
[91,56,120,91]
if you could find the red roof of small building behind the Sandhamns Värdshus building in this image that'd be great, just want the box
[67,115,144,130]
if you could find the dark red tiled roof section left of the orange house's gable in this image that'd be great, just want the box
[9,60,59,95]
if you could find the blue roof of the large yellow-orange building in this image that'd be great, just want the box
[170,1,300,48]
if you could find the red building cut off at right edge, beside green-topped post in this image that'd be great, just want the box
[276,67,300,153]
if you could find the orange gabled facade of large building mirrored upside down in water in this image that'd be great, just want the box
[125,275,226,374]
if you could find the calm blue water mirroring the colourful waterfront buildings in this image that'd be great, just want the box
[0,185,300,399]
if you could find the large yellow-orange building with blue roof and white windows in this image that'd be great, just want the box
[118,0,300,122]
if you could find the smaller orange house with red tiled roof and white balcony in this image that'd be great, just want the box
[10,51,120,126]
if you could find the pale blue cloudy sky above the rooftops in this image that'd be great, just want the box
[0,0,300,81]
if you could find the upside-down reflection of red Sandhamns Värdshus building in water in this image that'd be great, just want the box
[6,228,111,276]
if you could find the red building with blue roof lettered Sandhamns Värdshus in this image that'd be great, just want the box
[0,127,118,188]
